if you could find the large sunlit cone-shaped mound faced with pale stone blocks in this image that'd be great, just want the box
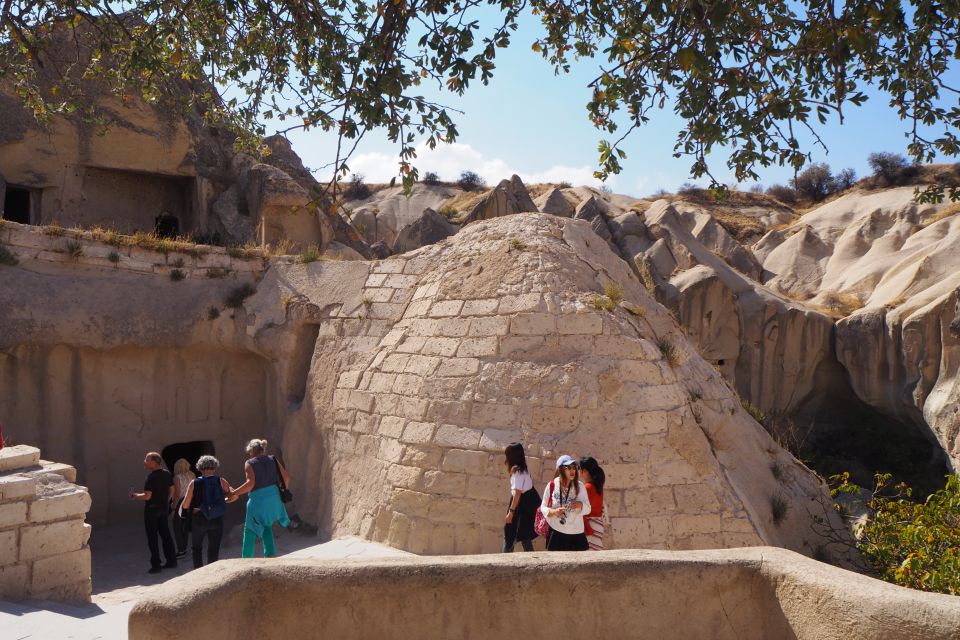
[302,216,848,554]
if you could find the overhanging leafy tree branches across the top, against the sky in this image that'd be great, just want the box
[0,0,960,192]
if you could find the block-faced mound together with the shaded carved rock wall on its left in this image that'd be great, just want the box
[0,214,848,555]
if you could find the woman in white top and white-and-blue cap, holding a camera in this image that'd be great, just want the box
[540,455,590,551]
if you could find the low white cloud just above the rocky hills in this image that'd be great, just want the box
[348,142,613,186]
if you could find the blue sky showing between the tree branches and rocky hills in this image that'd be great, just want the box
[282,11,952,197]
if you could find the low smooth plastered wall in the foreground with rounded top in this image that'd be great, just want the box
[129,547,960,640]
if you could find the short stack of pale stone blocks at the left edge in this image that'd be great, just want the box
[0,445,92,602]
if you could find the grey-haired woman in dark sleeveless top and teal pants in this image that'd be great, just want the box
[230,438,290,558]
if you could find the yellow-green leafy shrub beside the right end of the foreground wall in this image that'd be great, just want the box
[830,473,960,595]
